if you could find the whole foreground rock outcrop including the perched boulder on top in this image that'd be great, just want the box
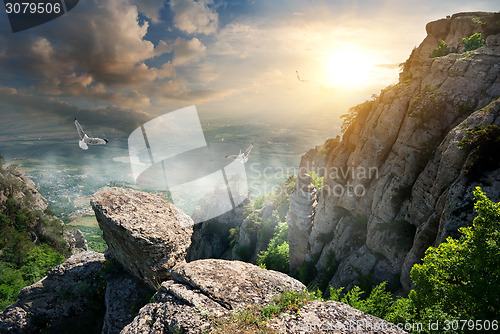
[0,188,404,334]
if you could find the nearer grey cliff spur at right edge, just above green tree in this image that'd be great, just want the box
[401,98,500,289]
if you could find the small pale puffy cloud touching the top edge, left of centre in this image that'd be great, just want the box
[170,0,219,35]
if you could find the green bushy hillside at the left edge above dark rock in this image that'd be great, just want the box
[0,160,69,310]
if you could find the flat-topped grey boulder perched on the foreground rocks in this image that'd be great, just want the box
[90,187,194,286]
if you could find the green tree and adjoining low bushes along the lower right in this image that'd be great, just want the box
[324,187,500,333]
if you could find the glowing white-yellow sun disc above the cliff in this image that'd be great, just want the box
[322,48,375,89]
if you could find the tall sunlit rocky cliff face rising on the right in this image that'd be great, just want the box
[288,13,500,291]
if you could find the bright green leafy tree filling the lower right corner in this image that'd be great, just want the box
[409,187,500,320]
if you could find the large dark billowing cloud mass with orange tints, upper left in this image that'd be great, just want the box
[0,0,178,110]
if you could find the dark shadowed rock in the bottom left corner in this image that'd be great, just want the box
[0,252,105,334]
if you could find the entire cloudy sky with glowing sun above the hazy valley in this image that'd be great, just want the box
[0,0,499,142]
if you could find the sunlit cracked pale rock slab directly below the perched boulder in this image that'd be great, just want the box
[121,259,305,334]
